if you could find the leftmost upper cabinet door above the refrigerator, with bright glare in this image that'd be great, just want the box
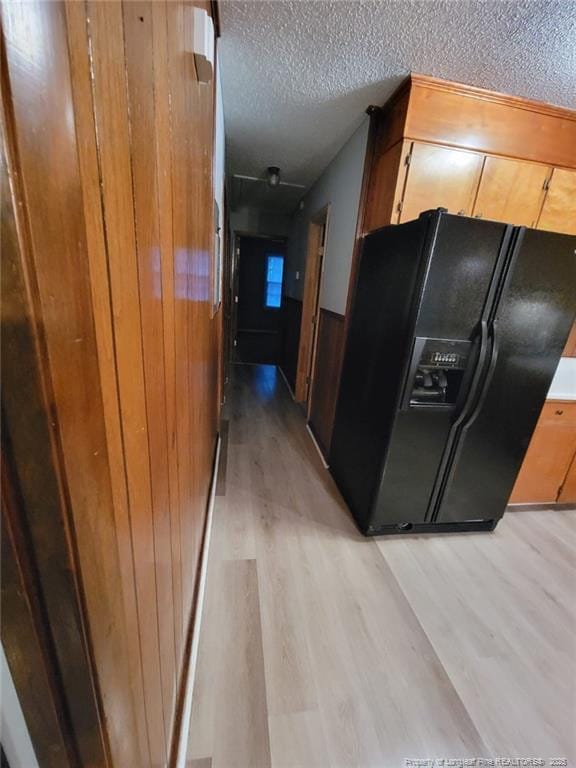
[400,142,484,223]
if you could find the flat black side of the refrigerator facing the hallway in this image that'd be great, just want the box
[330,218,429,530]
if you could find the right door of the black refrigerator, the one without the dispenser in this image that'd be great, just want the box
[436,230,576,523]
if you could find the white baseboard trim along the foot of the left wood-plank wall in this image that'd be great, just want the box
[170,435,222,768]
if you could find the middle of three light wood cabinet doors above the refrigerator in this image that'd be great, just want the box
[474,157,551,227]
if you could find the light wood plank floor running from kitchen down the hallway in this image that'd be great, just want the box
[188,366,576,768]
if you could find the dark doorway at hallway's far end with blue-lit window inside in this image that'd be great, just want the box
[234,235,286,365]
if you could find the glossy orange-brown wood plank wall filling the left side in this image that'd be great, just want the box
[2,0,221,768]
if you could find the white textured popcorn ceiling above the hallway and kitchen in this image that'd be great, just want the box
[219,0,576,192]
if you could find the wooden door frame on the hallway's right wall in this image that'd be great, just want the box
[294,203,330,408]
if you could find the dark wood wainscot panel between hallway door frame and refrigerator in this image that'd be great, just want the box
[309,308,344,457]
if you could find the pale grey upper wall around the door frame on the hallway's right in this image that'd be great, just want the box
[285,118,369,315]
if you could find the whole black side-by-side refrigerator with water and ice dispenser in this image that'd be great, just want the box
[330,209,576,535]
